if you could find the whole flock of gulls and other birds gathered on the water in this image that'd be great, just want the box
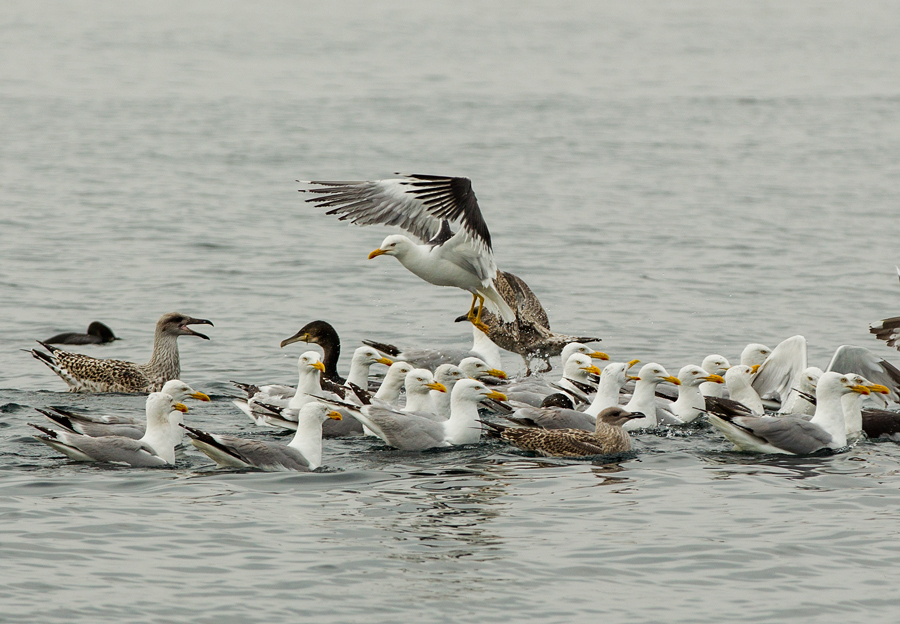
[17,175,900,470]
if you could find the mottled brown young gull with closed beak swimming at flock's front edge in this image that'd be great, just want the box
[482,406,644,457]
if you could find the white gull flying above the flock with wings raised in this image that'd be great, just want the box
[301,174,516,333]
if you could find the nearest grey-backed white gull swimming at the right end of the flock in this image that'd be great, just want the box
[707,371,869,455]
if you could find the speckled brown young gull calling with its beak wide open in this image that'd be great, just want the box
[31,312,212,392]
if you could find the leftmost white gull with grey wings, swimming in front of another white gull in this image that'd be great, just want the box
[28,392,187,468]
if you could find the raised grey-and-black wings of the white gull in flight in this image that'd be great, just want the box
[306,174,491,251]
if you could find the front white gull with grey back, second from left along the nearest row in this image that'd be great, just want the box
[182,401,341,471]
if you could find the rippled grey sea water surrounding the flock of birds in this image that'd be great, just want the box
[0,0,900,624]
